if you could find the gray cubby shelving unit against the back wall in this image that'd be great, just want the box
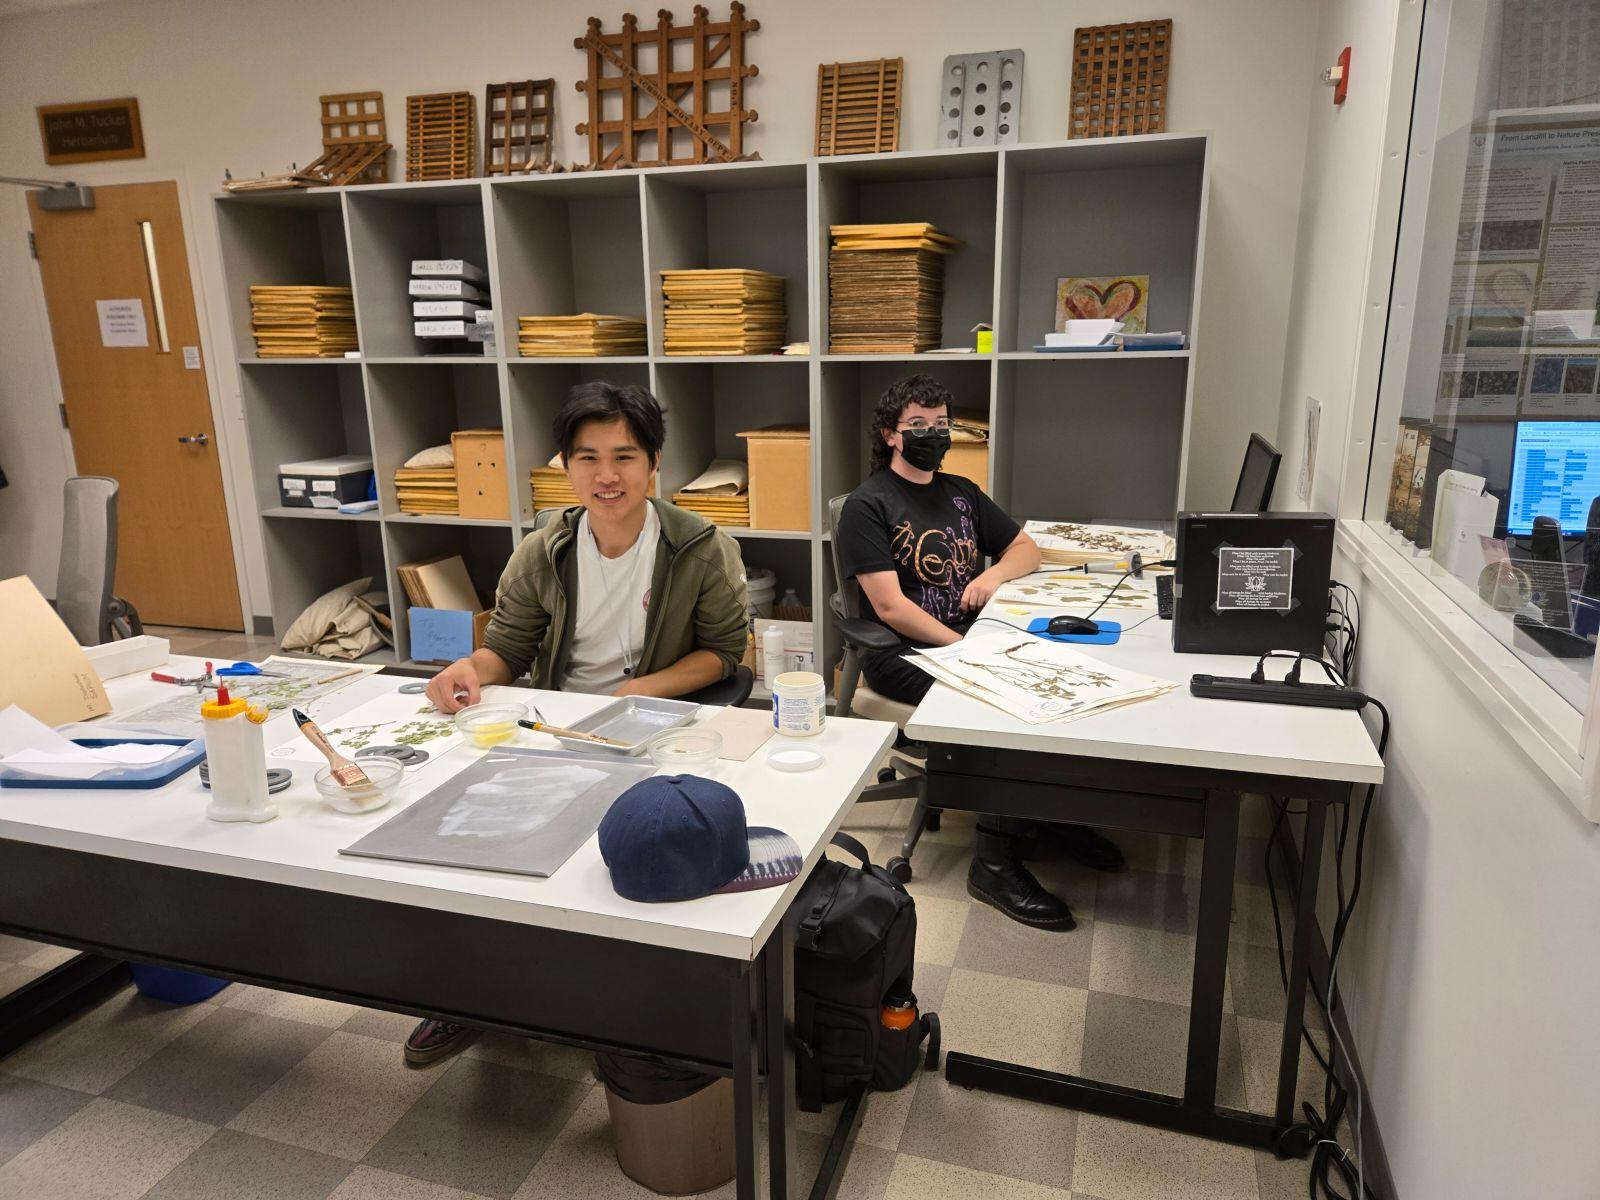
[216,134,1210,677]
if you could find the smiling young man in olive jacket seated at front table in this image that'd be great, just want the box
[406,382,749,1066]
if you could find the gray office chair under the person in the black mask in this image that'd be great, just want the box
[827,496,939,883]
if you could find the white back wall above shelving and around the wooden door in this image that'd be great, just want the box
[0,0,1315,613]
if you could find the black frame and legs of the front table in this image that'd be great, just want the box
[0,838,861,1200]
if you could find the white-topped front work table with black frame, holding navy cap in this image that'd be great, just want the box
[0,656,894,1197]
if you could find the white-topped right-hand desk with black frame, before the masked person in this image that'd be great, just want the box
[906,588,1384,1154]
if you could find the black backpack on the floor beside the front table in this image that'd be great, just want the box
[789,834,939,1112]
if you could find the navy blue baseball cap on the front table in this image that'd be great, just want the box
[600,774,805,902]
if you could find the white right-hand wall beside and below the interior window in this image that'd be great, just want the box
[1278,0,1600,1200]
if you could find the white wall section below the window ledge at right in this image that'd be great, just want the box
[1339,553,1600,1200]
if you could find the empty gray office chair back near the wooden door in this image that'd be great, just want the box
[56,475,144,646]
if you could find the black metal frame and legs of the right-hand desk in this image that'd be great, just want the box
[928,742,1352,1155]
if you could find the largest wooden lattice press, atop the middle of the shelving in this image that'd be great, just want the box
[573,0,762,170]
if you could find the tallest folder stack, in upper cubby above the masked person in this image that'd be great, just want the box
[827,221,962,354]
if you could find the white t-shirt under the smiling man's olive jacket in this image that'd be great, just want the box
[562,504,661,694]
